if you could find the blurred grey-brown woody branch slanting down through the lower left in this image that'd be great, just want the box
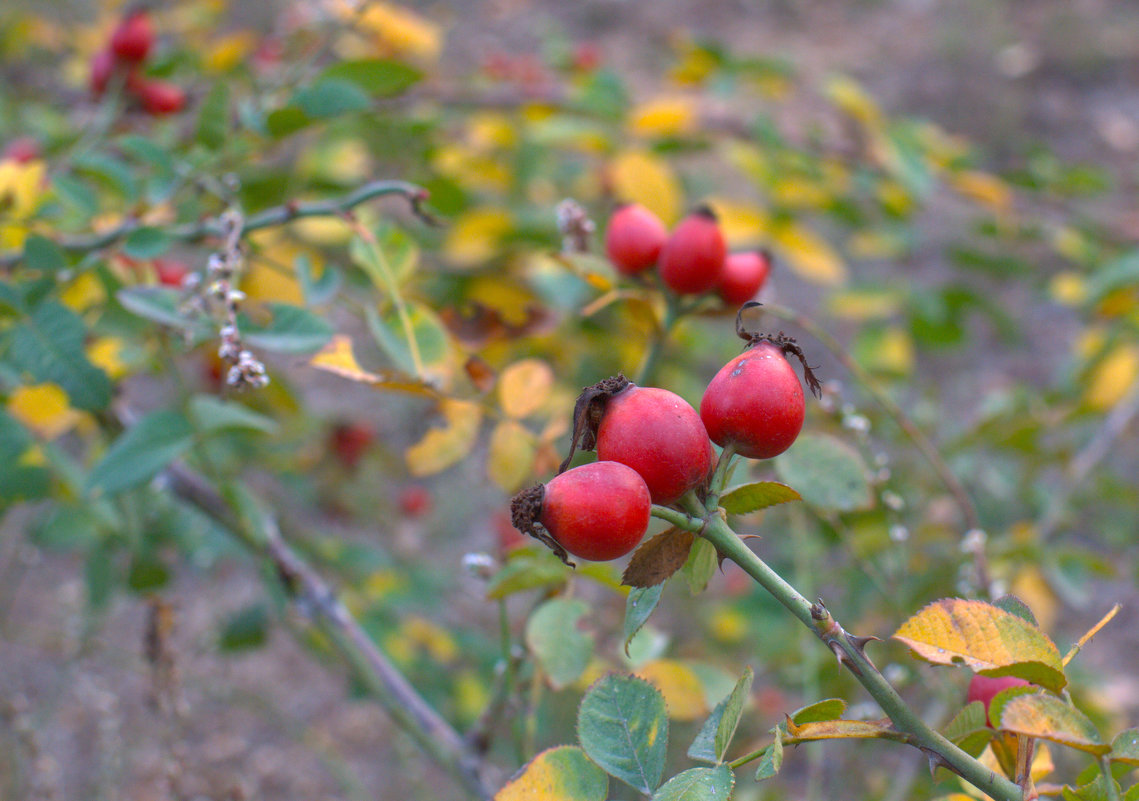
[164,463,491,800]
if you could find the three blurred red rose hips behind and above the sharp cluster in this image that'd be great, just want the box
[605,203,771,306]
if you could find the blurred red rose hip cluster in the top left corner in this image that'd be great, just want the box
[91,9,186,116]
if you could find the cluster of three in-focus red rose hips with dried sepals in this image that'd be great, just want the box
[510,303,819,562]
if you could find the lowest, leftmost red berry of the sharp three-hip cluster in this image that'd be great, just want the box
[539,461,653,562]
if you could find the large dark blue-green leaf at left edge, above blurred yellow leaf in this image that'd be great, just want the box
[8,301,110,411]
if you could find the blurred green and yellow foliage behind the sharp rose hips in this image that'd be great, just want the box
[0,0,1139,799]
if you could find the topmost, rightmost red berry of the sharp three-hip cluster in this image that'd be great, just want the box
[700,341,806,459]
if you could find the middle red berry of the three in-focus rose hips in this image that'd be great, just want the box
[597,384,714,505]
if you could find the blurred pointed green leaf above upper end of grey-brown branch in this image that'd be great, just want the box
[85,409,194,495]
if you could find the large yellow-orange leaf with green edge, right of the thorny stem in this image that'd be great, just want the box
[894,598,1067,692]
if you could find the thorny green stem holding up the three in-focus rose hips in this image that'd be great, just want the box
[653,501,1023,801]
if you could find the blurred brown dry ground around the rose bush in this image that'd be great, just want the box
[0,0,1139,801]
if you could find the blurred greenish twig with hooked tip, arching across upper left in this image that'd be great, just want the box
[0,181,439,268]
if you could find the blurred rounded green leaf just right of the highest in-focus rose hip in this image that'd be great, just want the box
[776,434,874,512]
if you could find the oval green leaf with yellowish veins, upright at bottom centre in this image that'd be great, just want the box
[577,673,669,795]
